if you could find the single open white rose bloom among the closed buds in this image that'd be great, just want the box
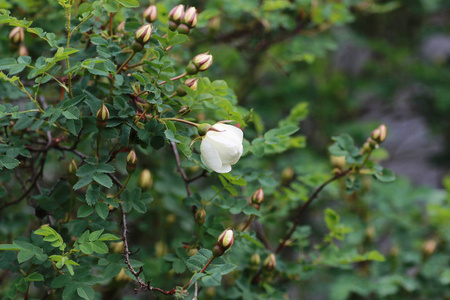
[200,123,244,173]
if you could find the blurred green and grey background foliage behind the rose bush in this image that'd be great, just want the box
[0,0,450,300]
